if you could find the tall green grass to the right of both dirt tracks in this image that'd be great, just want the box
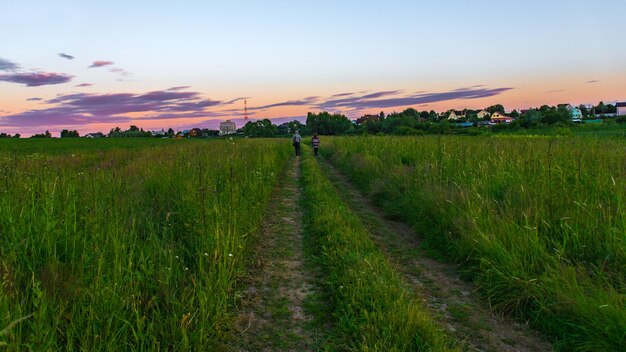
[322,136,626,351]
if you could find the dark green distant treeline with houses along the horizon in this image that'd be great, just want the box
[0,102,626,138]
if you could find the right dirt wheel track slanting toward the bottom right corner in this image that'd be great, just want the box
[320,158,552,352]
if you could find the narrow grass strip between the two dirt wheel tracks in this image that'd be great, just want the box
[302,147,453,351]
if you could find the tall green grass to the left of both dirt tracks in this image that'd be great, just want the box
[0,140,290,351]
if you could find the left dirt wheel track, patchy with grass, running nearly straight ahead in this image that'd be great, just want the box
[231,159,321,351]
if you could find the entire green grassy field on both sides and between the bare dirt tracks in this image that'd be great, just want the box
[0,135,626,351]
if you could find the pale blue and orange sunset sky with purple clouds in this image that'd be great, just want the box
[0,0,626,136]
